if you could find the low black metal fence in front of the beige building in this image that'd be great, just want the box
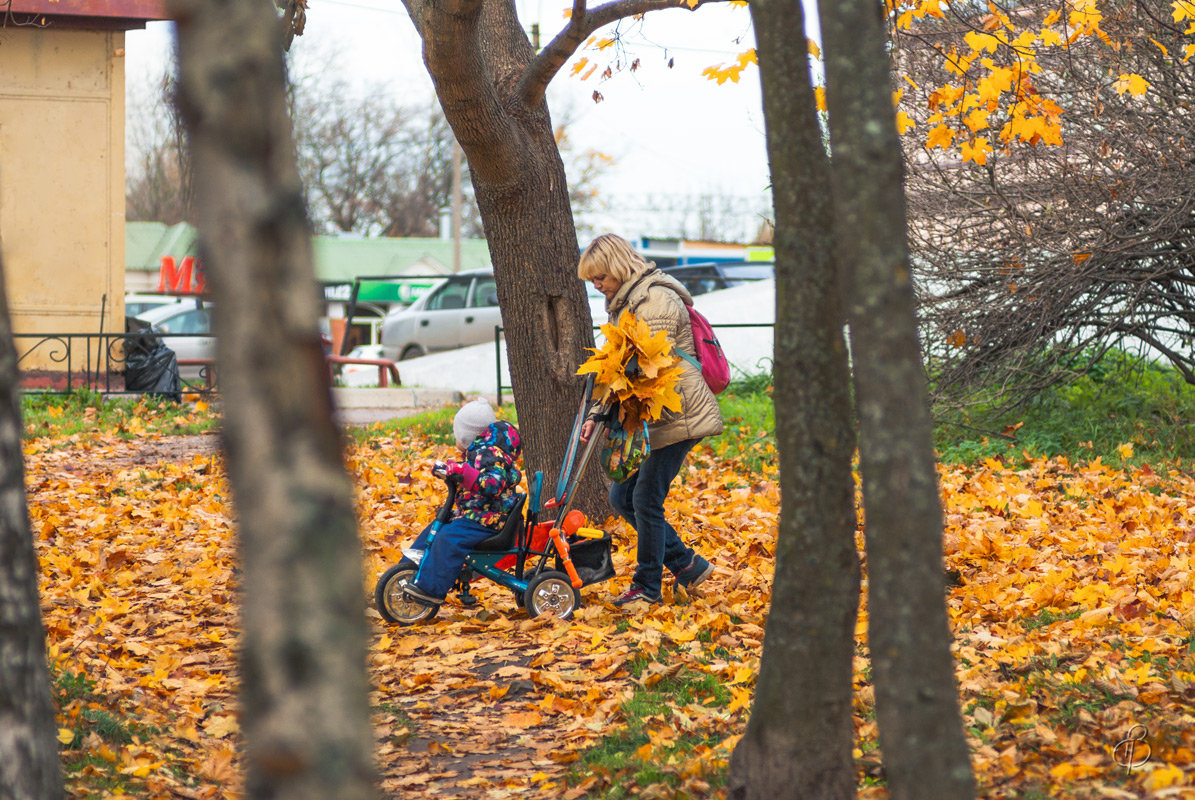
[13,332,219,395]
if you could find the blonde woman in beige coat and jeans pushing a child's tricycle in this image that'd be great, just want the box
[577,233,722,606]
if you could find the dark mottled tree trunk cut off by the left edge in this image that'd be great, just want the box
[0,249,63,800]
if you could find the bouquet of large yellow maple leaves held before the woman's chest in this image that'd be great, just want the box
[577,311,681,430]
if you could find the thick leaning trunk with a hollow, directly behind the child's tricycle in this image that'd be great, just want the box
[405,0,611,519]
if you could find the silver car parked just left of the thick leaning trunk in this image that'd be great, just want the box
[381,269,606,361]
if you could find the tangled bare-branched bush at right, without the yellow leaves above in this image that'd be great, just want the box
[895,0,1195,408]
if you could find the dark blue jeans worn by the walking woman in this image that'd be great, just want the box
[609,439,699,597]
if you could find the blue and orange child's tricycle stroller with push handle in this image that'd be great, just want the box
[374,375,614,625]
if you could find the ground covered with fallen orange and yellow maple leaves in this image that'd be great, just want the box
[16,423,1195,799]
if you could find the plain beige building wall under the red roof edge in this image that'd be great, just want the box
[0,26,124,361]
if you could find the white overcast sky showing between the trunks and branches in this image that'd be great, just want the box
[127,0,817,236]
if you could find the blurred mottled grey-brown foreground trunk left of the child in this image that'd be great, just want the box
[172,0,374,800]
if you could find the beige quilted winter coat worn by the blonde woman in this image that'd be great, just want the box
[606,269,722,450]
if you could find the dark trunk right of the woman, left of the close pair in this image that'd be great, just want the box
[729,0,859,800]
